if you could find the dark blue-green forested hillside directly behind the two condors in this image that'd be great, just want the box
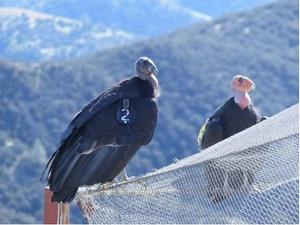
[0,0,299,223]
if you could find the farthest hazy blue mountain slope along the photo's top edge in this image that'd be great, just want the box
[0,0,275,36]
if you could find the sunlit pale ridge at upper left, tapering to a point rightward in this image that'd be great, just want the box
[0,7,134,61]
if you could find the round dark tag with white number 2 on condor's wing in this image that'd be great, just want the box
[117,98,136,124]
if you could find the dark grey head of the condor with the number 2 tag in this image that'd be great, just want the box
[135,56,158,77]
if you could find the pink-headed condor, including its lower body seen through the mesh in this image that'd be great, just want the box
[198,75,266,202]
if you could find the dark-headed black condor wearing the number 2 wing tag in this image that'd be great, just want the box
[42,57,159,203]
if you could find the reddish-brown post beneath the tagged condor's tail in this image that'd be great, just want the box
[44,187,58,224]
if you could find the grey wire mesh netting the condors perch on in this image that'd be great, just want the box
[76,104,299,224]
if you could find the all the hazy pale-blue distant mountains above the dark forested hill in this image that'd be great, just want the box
[0,0,274,61]
